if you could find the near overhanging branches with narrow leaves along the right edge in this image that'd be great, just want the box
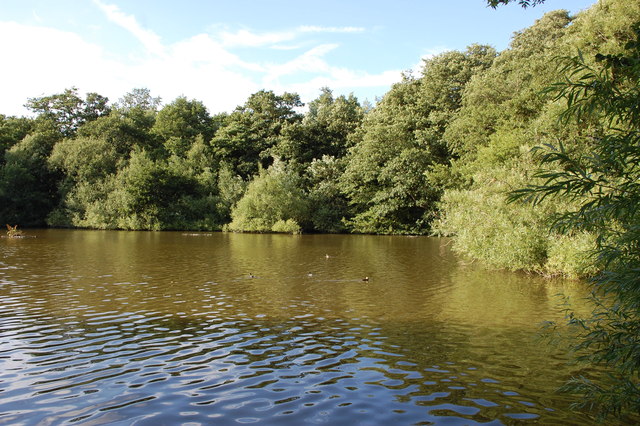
[512,21,640,418]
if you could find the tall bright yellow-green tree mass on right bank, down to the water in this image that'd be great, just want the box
[435,11,611,277]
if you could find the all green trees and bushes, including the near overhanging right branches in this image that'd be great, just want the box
[0,0,640,417]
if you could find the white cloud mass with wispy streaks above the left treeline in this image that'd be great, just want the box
[0,0,400,115]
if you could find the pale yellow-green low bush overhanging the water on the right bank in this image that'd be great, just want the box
[435,125,594,277]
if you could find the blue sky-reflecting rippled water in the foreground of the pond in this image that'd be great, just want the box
[0,311,580,424]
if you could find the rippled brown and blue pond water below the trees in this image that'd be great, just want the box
[0,230,591,425]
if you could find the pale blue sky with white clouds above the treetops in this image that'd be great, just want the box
[0,0,595,116]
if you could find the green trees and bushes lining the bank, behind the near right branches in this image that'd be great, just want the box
[0,0,640,277]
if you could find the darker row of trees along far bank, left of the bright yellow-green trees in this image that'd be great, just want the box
[0,49,497,234]
